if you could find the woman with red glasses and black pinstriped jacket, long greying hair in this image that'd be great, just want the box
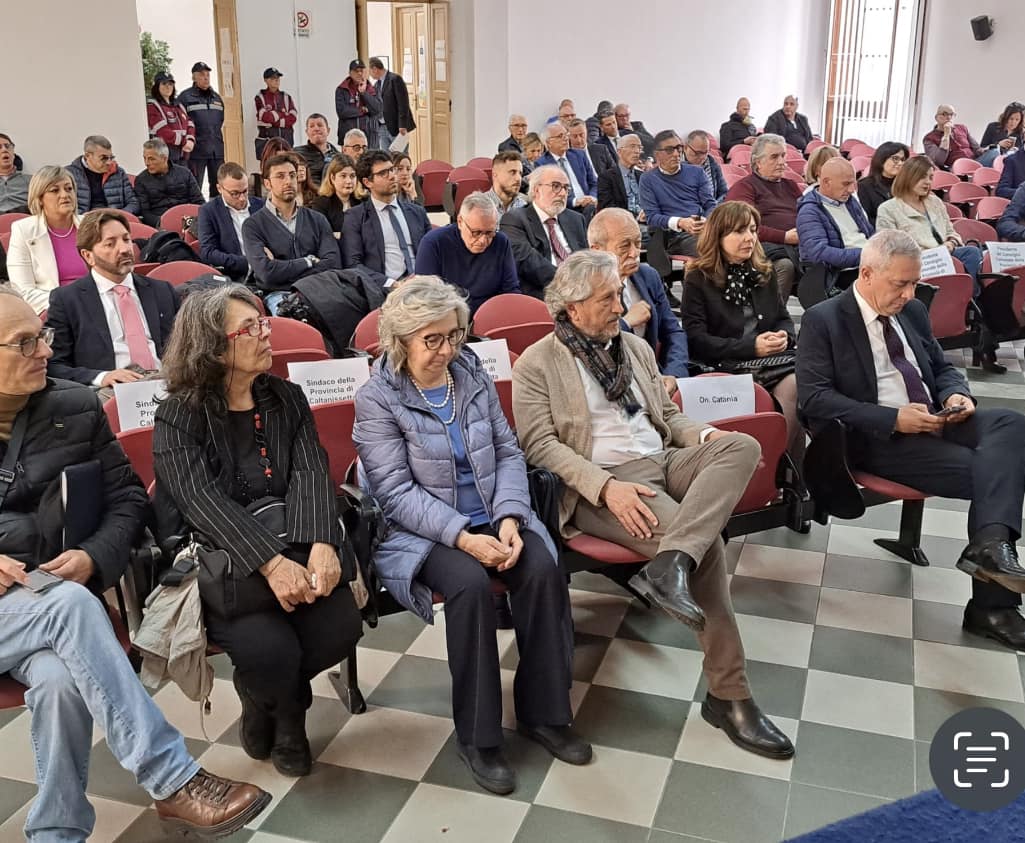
[153,284,362,776]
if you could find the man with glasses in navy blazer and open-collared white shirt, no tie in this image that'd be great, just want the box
[193,161,263,281]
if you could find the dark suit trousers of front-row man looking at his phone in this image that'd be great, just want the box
[856,409,1025,609]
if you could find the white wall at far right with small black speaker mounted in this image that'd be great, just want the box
[914,0,1025,143]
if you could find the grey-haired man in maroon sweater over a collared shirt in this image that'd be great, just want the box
[726,134,803,304]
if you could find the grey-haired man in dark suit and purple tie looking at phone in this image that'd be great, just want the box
[796,230,1025,650]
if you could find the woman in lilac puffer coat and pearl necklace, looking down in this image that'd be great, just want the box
[353,276,591,794]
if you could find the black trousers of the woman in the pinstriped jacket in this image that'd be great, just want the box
[204,573,363,717]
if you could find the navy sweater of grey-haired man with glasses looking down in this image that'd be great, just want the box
[416,223,520,313]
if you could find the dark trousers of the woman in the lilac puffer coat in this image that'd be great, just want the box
[417,528,573,747]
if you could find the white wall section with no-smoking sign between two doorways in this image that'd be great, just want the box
[237,0,365,169]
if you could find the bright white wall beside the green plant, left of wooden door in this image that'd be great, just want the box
[135,0,219,91]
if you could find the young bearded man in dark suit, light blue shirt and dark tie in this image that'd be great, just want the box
[341,150,431,287]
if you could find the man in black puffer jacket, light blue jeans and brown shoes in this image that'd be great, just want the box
[0,287,271,840]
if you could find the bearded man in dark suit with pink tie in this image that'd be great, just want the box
[46,209,178,388]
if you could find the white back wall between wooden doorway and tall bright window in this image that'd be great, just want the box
[451,0,829,160]
